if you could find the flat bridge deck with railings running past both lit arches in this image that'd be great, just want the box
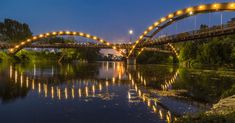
[0,23,235,53]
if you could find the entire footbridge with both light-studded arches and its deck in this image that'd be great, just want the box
[0,2,235,64]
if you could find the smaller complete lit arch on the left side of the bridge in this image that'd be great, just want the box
[8,31,126,56]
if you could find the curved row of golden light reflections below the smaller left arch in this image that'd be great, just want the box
[10,66,126,100]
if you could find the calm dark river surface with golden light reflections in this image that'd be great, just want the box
[0,62,235,123]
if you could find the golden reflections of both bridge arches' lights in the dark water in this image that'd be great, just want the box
[9,62,178,122]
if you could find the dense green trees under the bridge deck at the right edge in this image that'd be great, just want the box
[176,35,235,66]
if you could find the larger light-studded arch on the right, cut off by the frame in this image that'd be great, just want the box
[127,2,235,57]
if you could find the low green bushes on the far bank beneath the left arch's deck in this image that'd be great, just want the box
[5,48,101,63]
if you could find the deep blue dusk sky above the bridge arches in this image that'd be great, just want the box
[0,0,235,42]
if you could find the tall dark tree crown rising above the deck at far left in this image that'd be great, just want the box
[0,19,32,43]
